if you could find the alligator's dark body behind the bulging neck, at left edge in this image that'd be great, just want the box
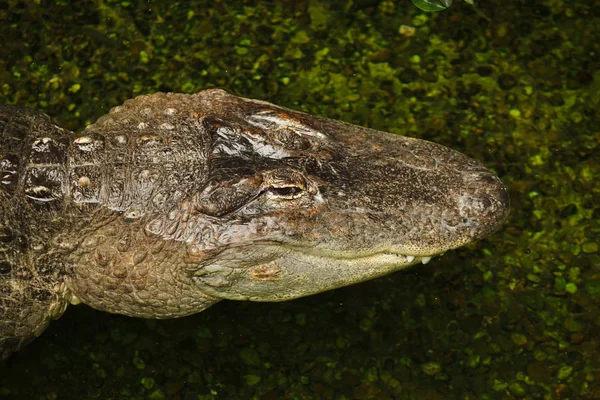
[0,105,70,358]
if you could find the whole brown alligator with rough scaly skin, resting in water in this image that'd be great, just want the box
[0,89,509,359]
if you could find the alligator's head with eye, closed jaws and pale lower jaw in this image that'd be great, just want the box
[85,90,509,301]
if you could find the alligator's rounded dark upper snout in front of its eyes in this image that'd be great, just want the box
[310,122,509,257]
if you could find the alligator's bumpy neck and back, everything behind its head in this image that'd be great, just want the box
[0,94,214,358]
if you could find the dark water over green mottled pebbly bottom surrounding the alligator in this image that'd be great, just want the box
[0,0,600,400]
